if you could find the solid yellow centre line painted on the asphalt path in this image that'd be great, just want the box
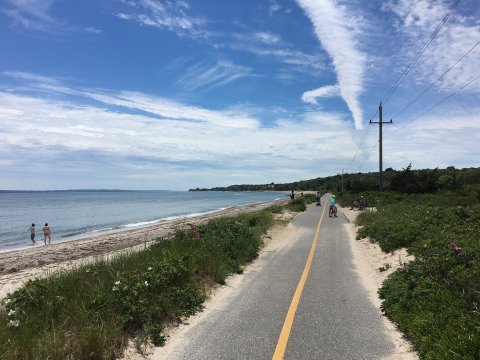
[272,206,327,360]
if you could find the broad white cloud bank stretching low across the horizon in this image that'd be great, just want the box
[0,73,480,189]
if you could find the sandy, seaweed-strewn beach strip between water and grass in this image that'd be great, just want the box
[0,199,286,299]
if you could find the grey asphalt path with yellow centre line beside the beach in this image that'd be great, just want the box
[159,199,394,360]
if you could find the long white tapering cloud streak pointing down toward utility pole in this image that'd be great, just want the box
[297,0,366,129]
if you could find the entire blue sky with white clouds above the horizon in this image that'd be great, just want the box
[0,0,480,190]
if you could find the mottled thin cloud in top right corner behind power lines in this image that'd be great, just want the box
[382,0,480,91]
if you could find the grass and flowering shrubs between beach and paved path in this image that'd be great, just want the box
[0,201,308,360]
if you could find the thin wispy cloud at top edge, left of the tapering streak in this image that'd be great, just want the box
[117,0,206,37]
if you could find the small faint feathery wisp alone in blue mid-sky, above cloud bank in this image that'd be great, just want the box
[176,60,252,91]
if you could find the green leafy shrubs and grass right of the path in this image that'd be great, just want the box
[358,193,480,360]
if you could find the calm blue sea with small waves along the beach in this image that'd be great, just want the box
[0,191,286,252]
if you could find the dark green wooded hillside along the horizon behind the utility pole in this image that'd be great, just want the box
[190,164,480,194]
